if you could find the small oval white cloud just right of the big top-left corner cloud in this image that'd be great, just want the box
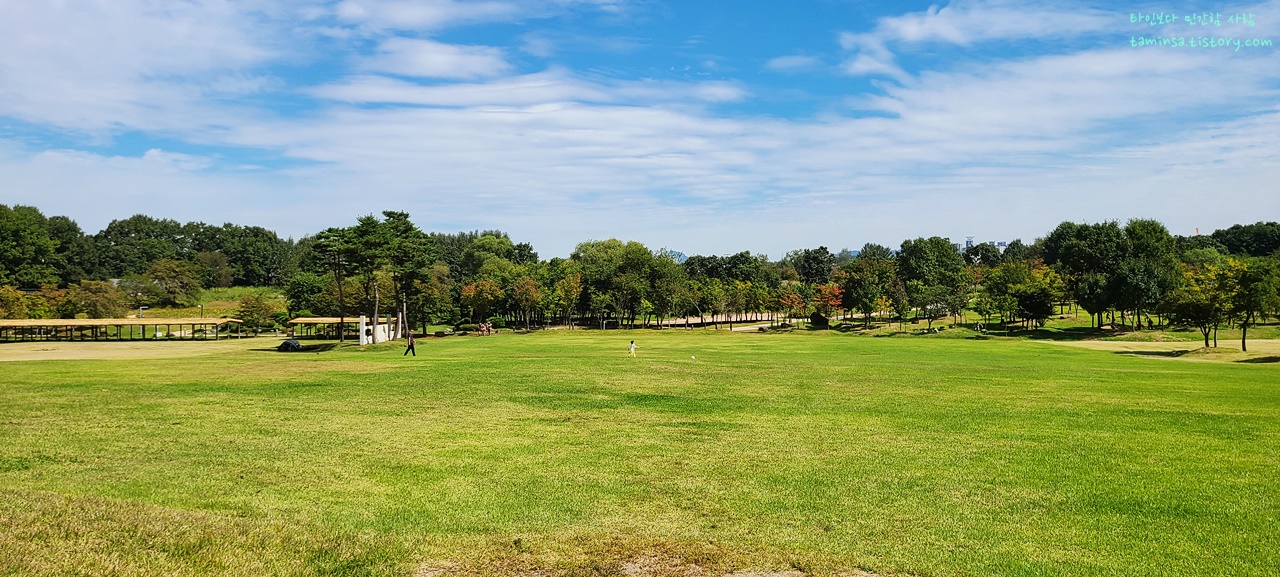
[364,37,511,79]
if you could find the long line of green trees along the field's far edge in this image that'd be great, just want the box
[0,205,1280,345]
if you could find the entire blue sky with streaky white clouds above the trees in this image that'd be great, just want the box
[0,0,1280,257]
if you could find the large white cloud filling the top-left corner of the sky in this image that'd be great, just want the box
[0,0,283,132]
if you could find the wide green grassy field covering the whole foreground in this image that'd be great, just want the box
[0,330,1280,577]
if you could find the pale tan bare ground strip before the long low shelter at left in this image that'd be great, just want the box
[0,335,284,362]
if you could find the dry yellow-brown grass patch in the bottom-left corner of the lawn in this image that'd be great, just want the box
[0,490,408,576]
